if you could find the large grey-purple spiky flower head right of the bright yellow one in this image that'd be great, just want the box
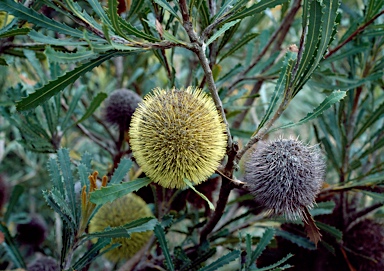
[244,138,325,219]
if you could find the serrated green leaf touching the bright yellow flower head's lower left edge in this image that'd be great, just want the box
[91,178,152,205]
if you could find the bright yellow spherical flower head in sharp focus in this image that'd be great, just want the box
[130,87,227,188]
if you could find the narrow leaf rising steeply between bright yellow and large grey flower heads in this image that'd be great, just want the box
[254,52,295,134]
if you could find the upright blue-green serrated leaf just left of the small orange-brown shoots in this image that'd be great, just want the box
[57,149,78,225]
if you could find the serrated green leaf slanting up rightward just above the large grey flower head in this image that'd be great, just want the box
[270,91,346,132]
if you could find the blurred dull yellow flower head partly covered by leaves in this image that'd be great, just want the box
[89,193,153,263]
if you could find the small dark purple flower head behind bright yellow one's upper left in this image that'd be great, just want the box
[104,88,142,130]
